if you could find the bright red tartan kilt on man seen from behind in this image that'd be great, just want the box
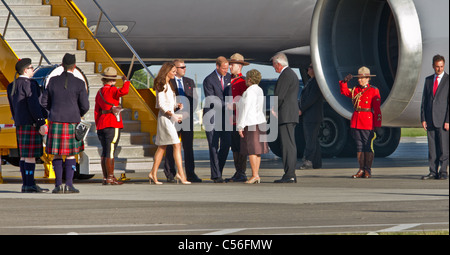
[45,122,84,156]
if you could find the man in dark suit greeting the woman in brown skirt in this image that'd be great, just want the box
[203,56,233,183]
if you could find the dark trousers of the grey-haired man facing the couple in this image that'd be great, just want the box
[278,123,297,179]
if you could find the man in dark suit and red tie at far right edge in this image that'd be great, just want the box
[421,55,449,180]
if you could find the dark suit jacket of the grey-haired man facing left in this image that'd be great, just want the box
[274,67,299,125]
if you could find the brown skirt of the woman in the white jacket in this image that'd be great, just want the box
[241,124,269,155]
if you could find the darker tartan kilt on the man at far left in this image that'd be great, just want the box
[16,125,44,158]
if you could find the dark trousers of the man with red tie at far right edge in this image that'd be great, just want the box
[427,127,449,177]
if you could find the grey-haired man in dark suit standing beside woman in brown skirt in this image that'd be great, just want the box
[272,53,299,183]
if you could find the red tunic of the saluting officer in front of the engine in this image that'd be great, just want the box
[339,81,381,130]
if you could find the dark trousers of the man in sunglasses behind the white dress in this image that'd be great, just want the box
[164,131,195,178]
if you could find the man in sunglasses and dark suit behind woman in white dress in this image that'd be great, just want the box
[164,59,202,182]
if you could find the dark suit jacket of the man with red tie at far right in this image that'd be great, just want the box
[420,73,449,128]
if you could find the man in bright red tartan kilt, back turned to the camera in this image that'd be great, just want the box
[42,53,89,193]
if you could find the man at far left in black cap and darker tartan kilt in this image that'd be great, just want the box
[7,58,48,193]
